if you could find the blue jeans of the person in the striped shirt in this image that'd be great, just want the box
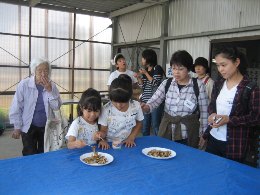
[142,104,164,136]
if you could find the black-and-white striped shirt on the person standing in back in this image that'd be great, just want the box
[138,65,164,103]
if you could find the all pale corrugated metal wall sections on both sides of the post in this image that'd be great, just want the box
[115,0,260,62]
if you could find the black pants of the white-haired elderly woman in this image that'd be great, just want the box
[22,125,45,156]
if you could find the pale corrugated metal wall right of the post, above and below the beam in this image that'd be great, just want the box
[167,0,260,62]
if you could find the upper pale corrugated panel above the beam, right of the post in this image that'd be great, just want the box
[169,0,260,36]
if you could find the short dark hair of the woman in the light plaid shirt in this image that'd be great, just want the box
[170,50,193,71]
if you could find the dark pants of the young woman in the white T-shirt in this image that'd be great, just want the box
[205,134,227,157]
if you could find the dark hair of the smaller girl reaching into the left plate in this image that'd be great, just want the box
[77,88,102,116]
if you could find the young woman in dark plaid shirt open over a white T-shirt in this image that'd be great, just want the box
[203,47,260,162]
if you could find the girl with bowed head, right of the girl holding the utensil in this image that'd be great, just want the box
[97,75,144,149]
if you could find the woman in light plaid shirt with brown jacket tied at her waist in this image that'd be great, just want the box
[141,50,208,148]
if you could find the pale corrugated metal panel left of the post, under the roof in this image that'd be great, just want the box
[116,5,162,43]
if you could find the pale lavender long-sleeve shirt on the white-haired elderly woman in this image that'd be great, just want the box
[9,76,61,133]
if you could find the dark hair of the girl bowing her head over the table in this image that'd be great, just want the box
[109,77,133,103]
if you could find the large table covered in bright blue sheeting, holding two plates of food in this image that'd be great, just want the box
[0,136,260,195]
